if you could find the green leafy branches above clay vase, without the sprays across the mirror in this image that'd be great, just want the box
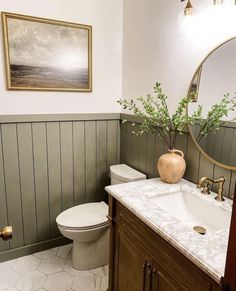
[118,83,202,149]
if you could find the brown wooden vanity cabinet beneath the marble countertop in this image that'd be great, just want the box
[108,196,221,291]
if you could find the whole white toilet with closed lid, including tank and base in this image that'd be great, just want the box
[56,164,146,270]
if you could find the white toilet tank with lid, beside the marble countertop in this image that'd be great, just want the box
[110,164,146,185]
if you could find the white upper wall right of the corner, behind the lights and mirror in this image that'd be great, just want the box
[122,0,236,112]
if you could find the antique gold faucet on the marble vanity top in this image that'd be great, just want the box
[197,176,225,202]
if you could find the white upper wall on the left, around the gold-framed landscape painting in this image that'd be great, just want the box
[0,0,123,114]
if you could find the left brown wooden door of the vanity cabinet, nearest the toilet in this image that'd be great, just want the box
[116,228,151,291]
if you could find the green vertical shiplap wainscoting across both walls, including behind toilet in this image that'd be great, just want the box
[0,113,236,261]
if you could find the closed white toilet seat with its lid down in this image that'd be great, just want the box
[56,202,109,231]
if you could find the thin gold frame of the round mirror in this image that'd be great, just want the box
[187,36,236,171]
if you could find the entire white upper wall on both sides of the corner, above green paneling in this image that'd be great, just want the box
[0,0,236,114]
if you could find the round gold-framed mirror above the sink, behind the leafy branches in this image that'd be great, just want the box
[188,37,236,170]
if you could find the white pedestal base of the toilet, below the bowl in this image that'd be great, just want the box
[72,229,109,271]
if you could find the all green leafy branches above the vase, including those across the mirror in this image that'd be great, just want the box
[117,83,236,149]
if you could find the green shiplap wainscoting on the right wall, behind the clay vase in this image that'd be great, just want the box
[120,114,236,198]
